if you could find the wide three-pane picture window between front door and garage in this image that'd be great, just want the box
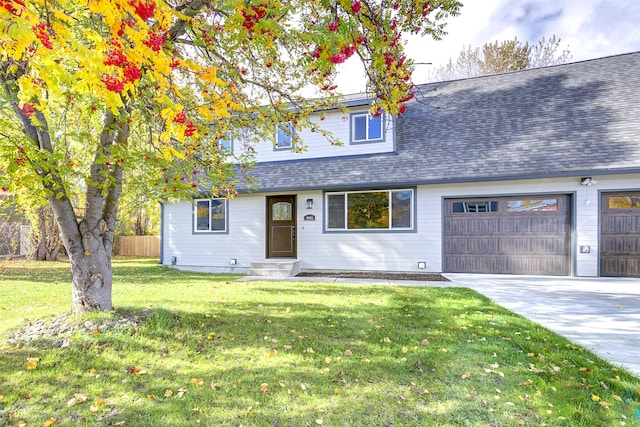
[325,189,414,231]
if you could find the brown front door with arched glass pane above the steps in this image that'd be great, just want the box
[267,196,297,258]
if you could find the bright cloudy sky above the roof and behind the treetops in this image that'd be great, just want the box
[339,0,640,93]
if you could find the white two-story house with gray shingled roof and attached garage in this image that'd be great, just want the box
[161,53,640,277]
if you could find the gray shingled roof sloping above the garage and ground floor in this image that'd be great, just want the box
[240,53,640,192]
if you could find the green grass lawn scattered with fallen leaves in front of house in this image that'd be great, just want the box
[0,259,640,427]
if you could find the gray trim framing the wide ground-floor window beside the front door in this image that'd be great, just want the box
[322,187,418,233]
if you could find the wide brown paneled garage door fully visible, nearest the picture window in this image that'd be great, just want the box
[444,194,571,276]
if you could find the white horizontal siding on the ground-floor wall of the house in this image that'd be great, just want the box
[162,174,640,277]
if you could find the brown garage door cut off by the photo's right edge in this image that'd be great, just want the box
[600,192,640,277]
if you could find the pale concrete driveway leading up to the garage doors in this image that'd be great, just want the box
[445,274,640,377]
